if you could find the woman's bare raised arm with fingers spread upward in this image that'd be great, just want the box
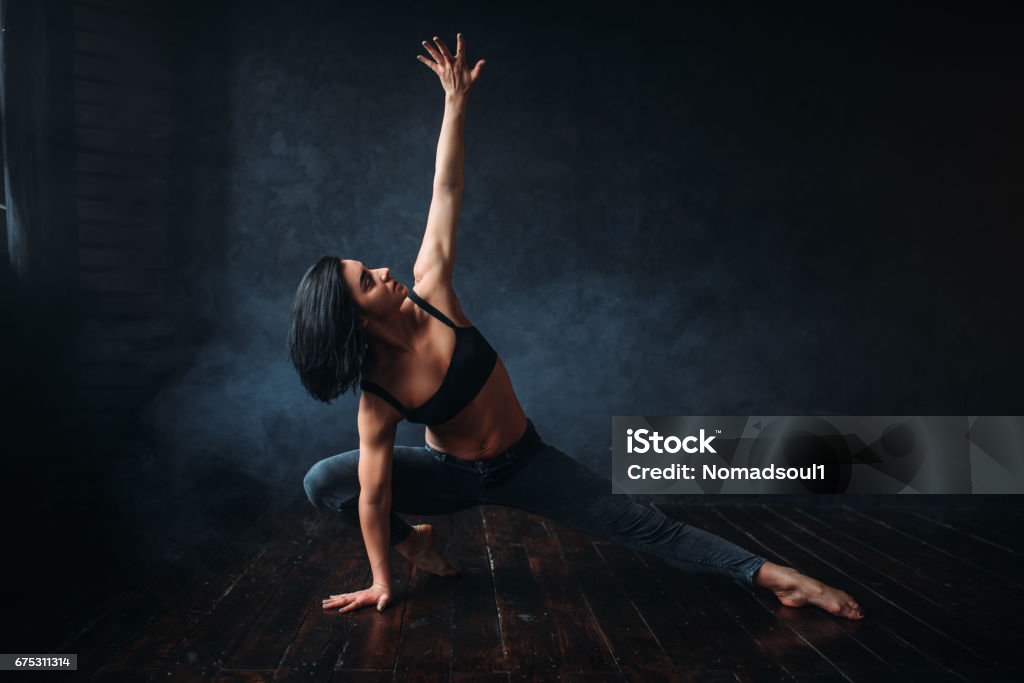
[413,34,485,283]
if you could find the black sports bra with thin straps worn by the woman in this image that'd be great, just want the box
[359,290,498,426]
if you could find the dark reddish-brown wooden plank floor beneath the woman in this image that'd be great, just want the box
[59,499,1024,683]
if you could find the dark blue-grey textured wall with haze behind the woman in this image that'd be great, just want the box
[146,1,1024,487]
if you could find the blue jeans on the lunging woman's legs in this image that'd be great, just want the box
[303,421,765,585]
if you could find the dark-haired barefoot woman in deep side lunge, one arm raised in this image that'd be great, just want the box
[289,34,862,618]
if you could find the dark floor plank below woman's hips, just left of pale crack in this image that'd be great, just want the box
[447,507,508,680]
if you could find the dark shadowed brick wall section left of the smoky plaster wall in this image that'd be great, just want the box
[74,0,174,432]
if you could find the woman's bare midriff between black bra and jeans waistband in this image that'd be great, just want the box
[424,357,526,460]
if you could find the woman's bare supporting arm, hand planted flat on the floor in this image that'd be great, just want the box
[324,393,400,612]
